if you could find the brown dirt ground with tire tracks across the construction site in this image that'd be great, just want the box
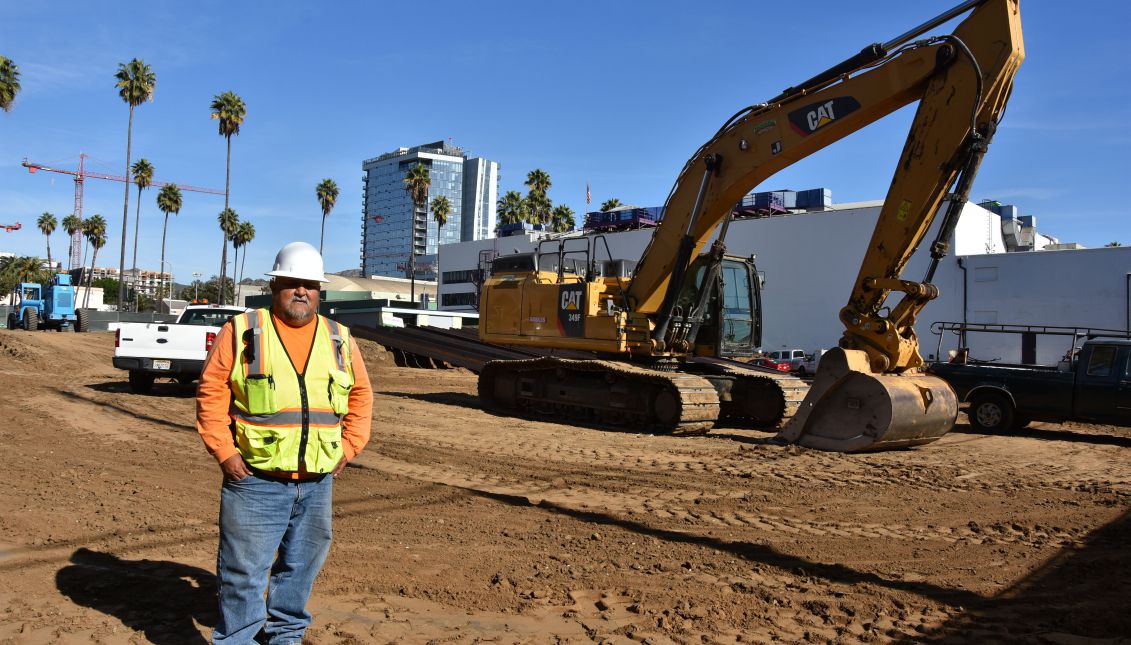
[0,330,1131,644]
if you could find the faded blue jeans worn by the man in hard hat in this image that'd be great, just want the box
[213,466,334,644]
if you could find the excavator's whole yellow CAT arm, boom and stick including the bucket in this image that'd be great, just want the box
[627,0,1025,452]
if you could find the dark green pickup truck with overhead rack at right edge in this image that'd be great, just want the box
[927,324,1131,432]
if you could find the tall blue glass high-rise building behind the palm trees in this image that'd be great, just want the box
[361,141,499,280]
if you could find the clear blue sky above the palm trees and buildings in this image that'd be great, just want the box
[0,0,1131,282]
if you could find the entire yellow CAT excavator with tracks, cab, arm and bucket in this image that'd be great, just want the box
[478,0,1025,452]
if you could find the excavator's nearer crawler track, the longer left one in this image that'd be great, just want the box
[480,356,719,435]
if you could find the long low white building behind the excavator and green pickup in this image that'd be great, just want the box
[439,201,1131,362]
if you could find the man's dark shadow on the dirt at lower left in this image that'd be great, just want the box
[55,549,217,645]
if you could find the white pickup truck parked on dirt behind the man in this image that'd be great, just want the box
[114,304,248,394]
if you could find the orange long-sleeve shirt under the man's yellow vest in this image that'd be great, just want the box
[197,315,373,462]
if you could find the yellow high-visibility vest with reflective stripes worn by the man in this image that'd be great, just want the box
[228,309,354,473]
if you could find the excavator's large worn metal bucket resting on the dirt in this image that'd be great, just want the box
[777,349,958,453]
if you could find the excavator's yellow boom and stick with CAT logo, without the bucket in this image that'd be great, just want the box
[628,0,1024,350]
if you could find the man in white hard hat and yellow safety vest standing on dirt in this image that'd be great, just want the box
[197,242,373,644]
